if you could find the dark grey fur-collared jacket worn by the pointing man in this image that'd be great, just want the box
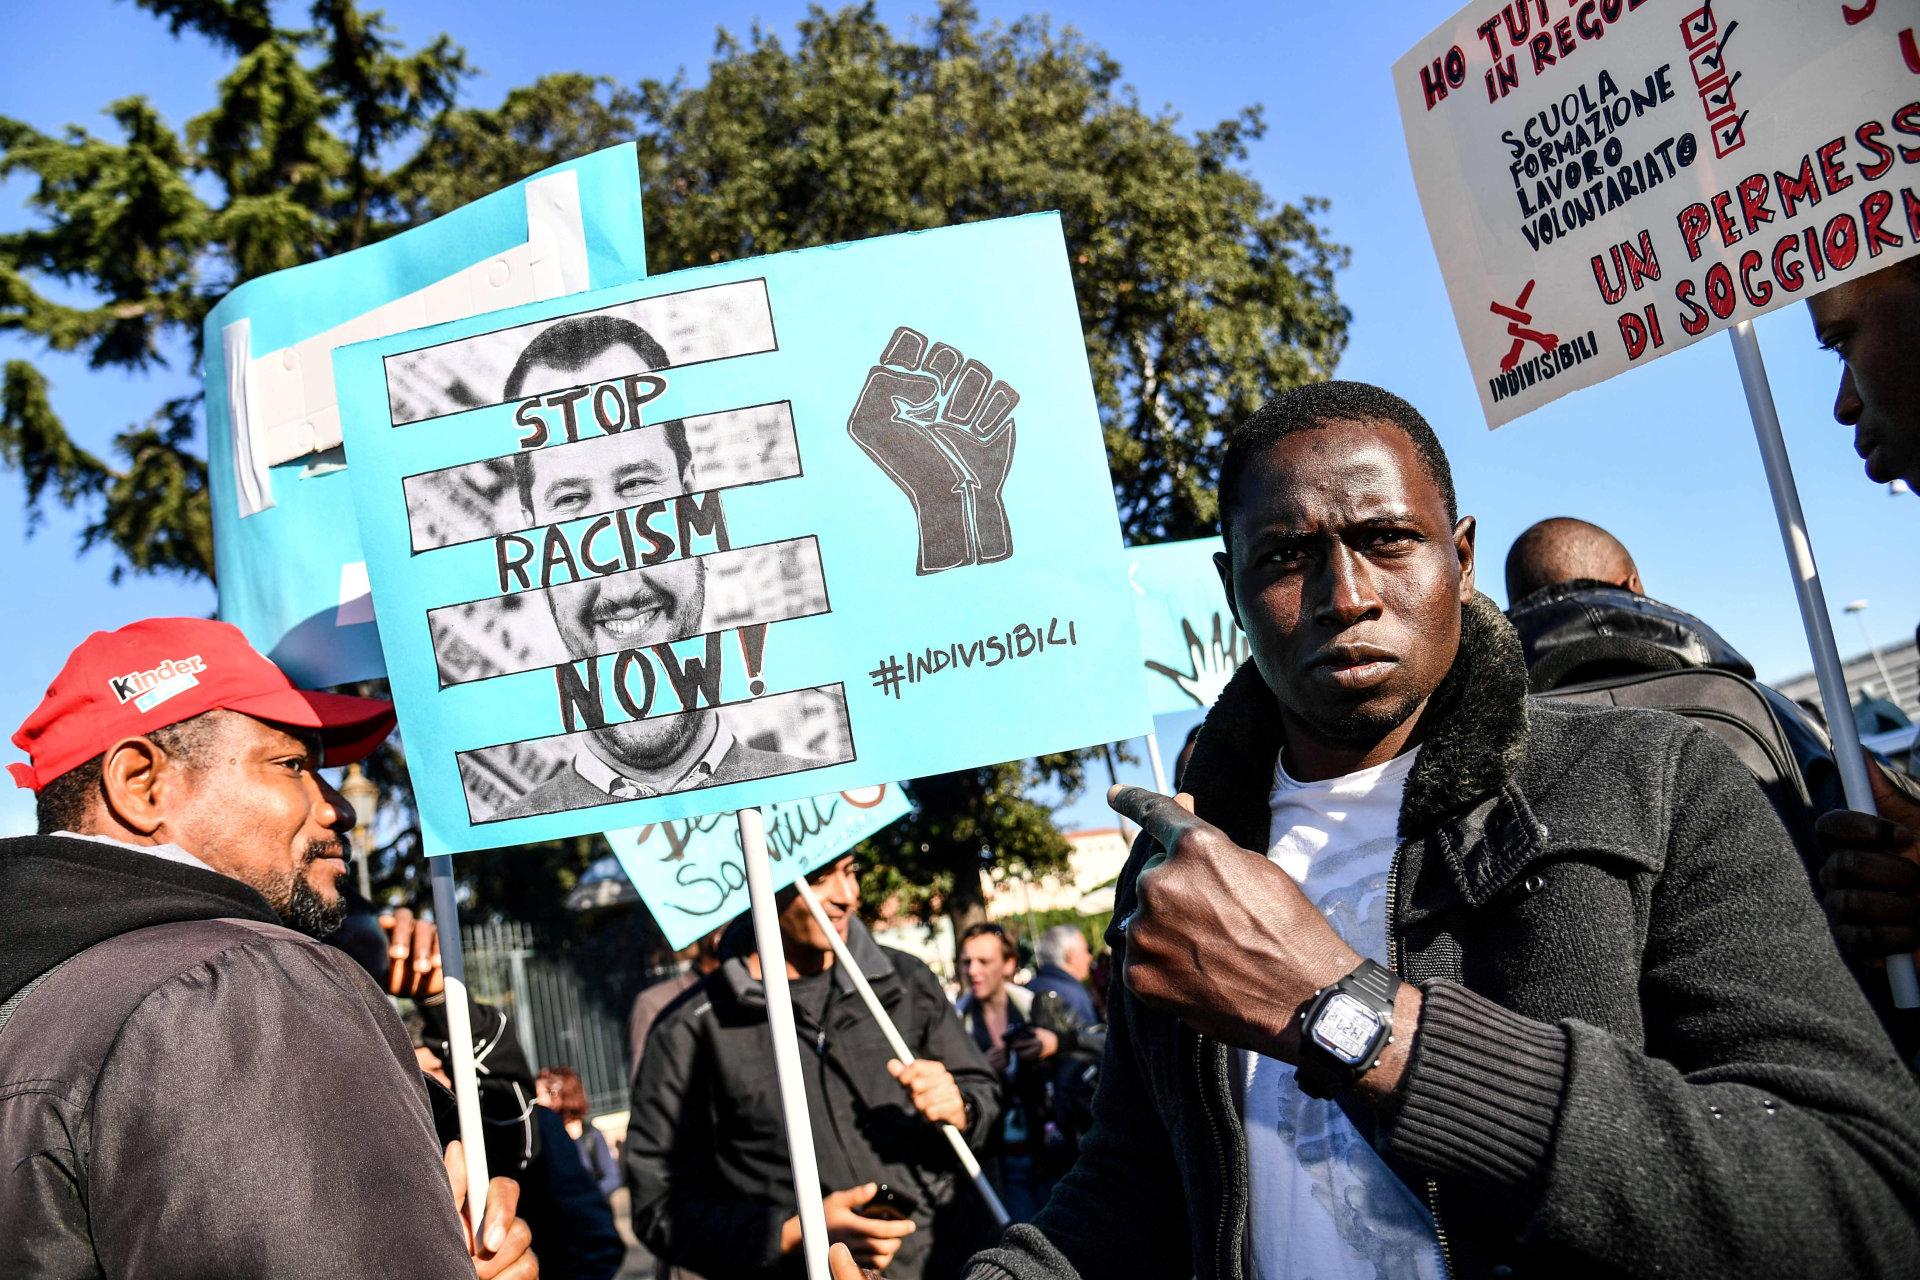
[970,597,1920,1280]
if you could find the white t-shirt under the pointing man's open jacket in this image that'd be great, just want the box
[1240,750,1442,1280]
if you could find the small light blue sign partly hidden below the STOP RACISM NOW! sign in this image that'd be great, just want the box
[607,783,914,950]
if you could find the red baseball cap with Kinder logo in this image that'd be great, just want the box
[6,618,394,791]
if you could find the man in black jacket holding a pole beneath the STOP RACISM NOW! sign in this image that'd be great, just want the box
[624,858,1000,1280]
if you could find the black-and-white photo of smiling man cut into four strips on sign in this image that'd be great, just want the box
[378,282,852,821]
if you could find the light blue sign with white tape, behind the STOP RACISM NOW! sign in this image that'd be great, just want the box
[205,144,647,685]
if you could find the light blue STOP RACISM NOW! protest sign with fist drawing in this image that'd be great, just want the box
[334,215,1148,854]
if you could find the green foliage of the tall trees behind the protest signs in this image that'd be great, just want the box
[0,0,1348,940]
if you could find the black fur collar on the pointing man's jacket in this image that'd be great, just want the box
[1187,595,1526,850]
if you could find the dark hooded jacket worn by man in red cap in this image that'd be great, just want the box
[0,837,472,1280]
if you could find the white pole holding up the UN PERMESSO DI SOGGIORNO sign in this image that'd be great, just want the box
[1726,320,1920,1009]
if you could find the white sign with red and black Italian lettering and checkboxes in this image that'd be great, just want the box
[1394,0,1920,426]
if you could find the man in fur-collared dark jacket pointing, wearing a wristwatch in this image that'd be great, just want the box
[970,384,1920,1280]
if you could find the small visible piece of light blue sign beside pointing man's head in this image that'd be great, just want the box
[1127,537,1248,716]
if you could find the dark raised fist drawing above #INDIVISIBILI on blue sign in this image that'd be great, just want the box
[847,324,1020,574]
